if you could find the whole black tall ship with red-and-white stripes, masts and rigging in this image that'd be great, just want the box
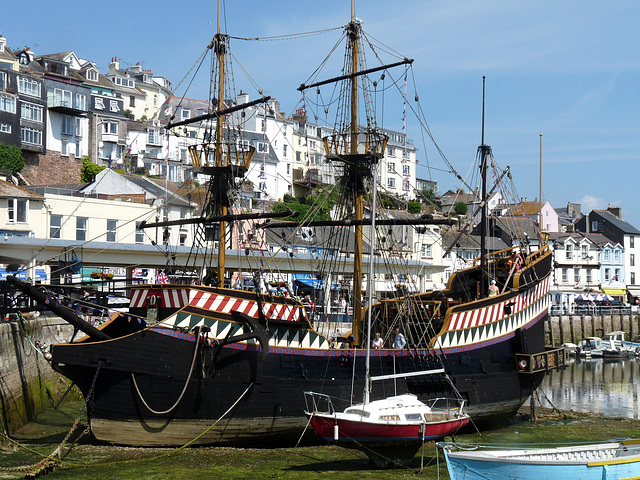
[9,3,557,446]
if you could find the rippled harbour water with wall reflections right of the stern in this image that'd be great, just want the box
[539,359,640,420]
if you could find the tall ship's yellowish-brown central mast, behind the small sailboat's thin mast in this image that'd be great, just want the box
[349,16,364,344]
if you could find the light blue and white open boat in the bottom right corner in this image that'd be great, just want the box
[438,440,640,480]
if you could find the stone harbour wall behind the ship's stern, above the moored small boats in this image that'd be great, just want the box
[545,313,640,347]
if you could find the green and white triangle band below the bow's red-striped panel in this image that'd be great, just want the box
[158,312,329,350]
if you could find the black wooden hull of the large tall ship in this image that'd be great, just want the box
[52,272,547,446]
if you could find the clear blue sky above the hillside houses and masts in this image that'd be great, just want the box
[0,0,640,228]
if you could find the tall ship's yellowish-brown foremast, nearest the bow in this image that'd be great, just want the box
[214,4,228,287]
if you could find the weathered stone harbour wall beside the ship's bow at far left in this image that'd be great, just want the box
[0,318,73,443]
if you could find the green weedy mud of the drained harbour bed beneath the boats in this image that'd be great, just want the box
[0,394,640,480]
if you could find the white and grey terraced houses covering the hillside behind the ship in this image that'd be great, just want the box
[0,33,640,303]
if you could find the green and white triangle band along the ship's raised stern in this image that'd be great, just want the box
[436,295,549,348]
